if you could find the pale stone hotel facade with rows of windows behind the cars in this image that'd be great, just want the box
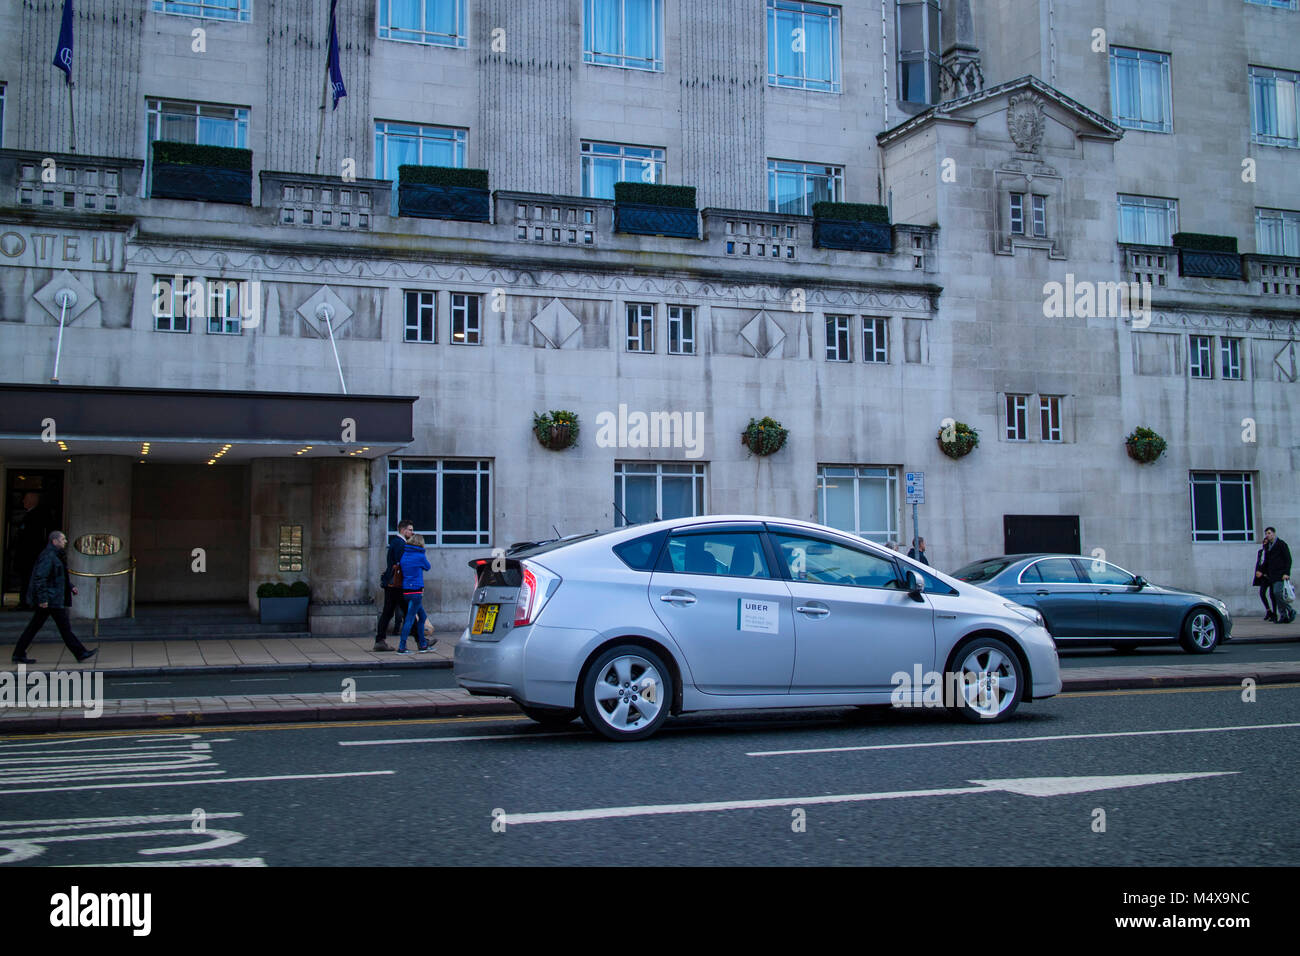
[0,0,1300,632]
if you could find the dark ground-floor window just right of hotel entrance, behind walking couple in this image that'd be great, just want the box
[387,458,491,548]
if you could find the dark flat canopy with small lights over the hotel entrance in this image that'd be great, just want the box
[0,384,419,463]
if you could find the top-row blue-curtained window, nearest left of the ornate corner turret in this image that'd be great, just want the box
[767,0,840,92]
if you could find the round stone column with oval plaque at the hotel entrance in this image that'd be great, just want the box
[62,455,135,619]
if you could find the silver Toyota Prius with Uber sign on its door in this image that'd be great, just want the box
[455,515,1061,740]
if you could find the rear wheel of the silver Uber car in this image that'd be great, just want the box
[582,644,673,740]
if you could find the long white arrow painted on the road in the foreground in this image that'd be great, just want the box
[501,770,1239,826]
